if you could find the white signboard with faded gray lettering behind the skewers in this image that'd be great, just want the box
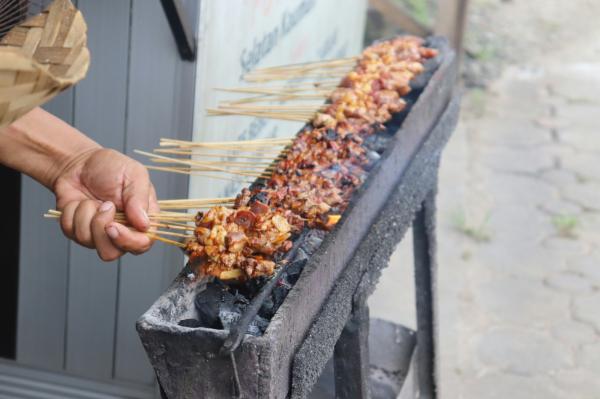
[190,0,367,198]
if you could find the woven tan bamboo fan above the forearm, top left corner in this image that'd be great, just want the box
[0,0,90,127]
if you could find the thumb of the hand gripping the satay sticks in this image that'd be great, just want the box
[122,166,152,231]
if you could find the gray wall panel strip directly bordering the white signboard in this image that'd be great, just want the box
[115,0,194,383]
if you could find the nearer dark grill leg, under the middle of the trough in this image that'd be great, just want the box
[333,298,369,399]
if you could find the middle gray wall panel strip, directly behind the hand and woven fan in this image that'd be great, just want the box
[66,0,130,379]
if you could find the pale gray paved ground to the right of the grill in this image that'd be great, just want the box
[371,1,600,399]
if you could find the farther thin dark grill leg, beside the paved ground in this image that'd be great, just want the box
[413,190,437,399]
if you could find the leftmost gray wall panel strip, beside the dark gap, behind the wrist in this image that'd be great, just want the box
[17,90,73,370]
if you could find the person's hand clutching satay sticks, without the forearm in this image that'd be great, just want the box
[52,146,159,261]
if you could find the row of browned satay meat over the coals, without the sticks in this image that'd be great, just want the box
[187,37,436,280]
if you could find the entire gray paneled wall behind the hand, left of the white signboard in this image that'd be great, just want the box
[17,0,199,386]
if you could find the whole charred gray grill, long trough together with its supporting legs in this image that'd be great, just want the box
[137,38,459,399]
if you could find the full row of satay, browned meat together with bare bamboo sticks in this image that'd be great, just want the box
[48,36,437,280]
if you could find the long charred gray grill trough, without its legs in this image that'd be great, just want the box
[137,38,458,399]
